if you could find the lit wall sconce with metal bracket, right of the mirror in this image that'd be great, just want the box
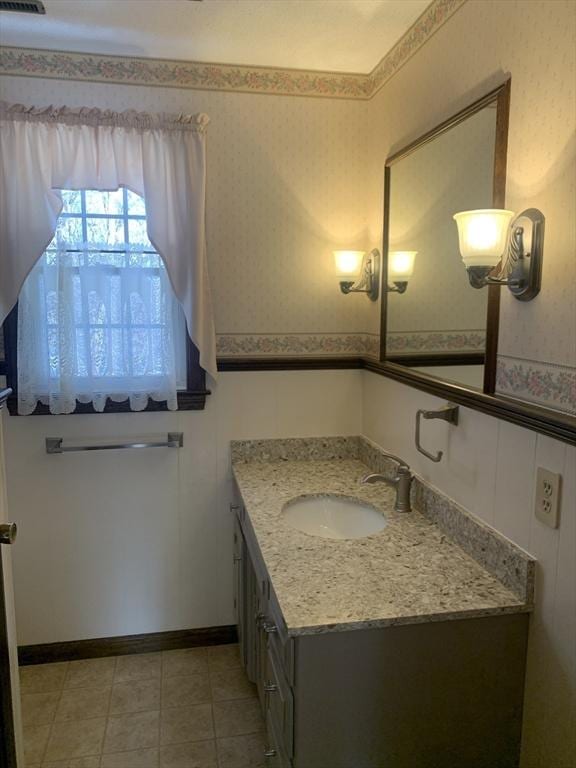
[454,208,544,301]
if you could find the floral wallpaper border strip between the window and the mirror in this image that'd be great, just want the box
[216,333,380,357]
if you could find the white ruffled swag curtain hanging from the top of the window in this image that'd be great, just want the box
[0,103,216,377]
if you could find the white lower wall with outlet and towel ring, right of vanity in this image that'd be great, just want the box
[363,372,576,768]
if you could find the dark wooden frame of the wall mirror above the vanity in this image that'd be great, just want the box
[380,79,510,394]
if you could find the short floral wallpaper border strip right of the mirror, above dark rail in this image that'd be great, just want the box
[496,355,576,416]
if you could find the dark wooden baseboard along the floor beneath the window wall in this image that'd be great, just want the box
[18,625,238,666]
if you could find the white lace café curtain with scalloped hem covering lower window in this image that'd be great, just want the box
[18,226,186,415]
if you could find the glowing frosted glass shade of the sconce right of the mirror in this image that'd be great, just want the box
[454,208,516,268]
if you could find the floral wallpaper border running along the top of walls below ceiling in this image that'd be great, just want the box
[0,0,466,99]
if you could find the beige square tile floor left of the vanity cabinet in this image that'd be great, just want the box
[20,645,264,768]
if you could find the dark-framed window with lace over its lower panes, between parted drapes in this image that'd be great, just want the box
[5,188,205,414]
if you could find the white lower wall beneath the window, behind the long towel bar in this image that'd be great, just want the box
[5,370,362,644]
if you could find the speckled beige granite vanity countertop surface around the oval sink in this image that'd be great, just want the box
[233,442,532,635]
